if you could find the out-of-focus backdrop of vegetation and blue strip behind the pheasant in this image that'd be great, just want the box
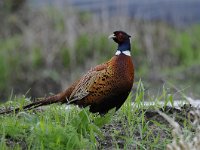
[0,0,200,101]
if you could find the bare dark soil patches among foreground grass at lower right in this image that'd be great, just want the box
[97,105,196,149]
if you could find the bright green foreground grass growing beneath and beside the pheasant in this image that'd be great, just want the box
[0,81,198,150]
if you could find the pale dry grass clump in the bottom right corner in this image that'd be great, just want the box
[158,103,200,150]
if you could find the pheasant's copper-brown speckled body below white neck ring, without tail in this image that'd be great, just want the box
[69,54,134,114]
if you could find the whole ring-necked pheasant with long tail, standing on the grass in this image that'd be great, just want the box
[0,31,134,114]
